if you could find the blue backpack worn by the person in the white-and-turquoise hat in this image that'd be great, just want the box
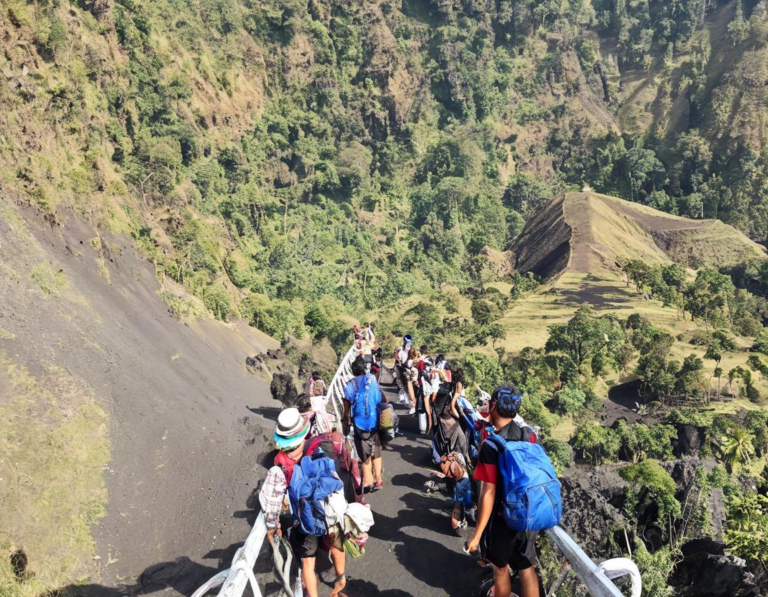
[288,454,344,537]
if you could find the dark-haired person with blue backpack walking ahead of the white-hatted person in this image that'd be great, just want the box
[344,357,384,493]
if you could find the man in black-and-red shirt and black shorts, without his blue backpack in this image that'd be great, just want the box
[466,385,539,597]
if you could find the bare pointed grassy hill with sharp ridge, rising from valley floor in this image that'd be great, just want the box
[512,192,766,280]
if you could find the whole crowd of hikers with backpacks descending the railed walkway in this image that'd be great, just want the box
[259,324,560,597]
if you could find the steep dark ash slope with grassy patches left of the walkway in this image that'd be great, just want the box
[0,201,277,593]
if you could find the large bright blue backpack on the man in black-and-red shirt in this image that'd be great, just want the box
[488,434,563,531]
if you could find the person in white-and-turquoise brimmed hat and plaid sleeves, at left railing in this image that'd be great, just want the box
[259,408,347,597]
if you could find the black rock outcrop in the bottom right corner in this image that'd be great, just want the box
[671,539,761,597]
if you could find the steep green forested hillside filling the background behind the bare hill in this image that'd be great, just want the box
[0,0,768,337]
